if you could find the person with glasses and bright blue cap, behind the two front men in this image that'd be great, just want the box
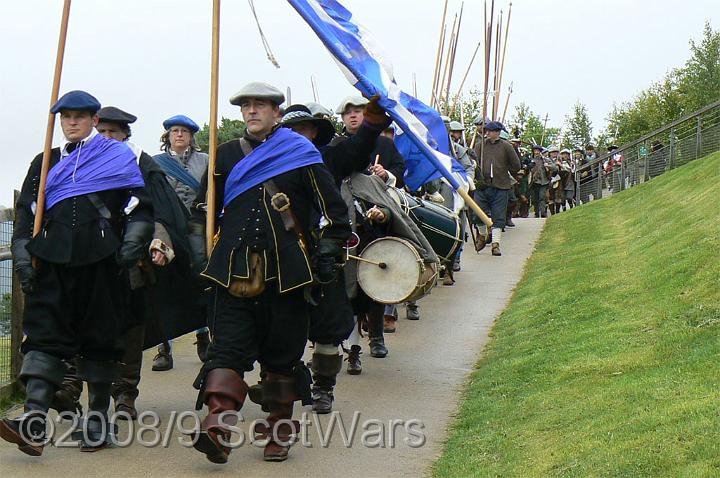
[152,115,210,371]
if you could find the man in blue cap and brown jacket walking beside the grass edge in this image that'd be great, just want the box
[475,121,520,256]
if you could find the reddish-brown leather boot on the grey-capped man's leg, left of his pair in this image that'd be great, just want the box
[192,368,248,463]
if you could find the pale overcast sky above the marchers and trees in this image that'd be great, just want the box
[0,0,720,205]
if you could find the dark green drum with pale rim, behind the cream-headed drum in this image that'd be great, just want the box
[388,188,462,262]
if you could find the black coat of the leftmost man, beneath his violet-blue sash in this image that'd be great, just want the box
[13,148,153,266]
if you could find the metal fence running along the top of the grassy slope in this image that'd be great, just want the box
[575,101,720,203]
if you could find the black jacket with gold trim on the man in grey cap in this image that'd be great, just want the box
[198,133,350,293]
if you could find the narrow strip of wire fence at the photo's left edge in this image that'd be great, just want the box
[0,214,14,386]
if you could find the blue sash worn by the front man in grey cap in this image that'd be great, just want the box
[223,128,323,207]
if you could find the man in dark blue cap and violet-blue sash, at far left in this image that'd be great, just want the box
[0,91,153,456]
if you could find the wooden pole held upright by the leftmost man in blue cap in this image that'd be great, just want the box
[33,0,70,237]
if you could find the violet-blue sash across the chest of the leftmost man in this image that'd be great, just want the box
[45,134,145,209]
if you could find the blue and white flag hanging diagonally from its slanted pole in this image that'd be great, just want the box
[288,0,465,190]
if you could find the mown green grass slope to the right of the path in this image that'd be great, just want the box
[433,154,720,477]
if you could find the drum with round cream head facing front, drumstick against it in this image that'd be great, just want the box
[357,237,438,304]
